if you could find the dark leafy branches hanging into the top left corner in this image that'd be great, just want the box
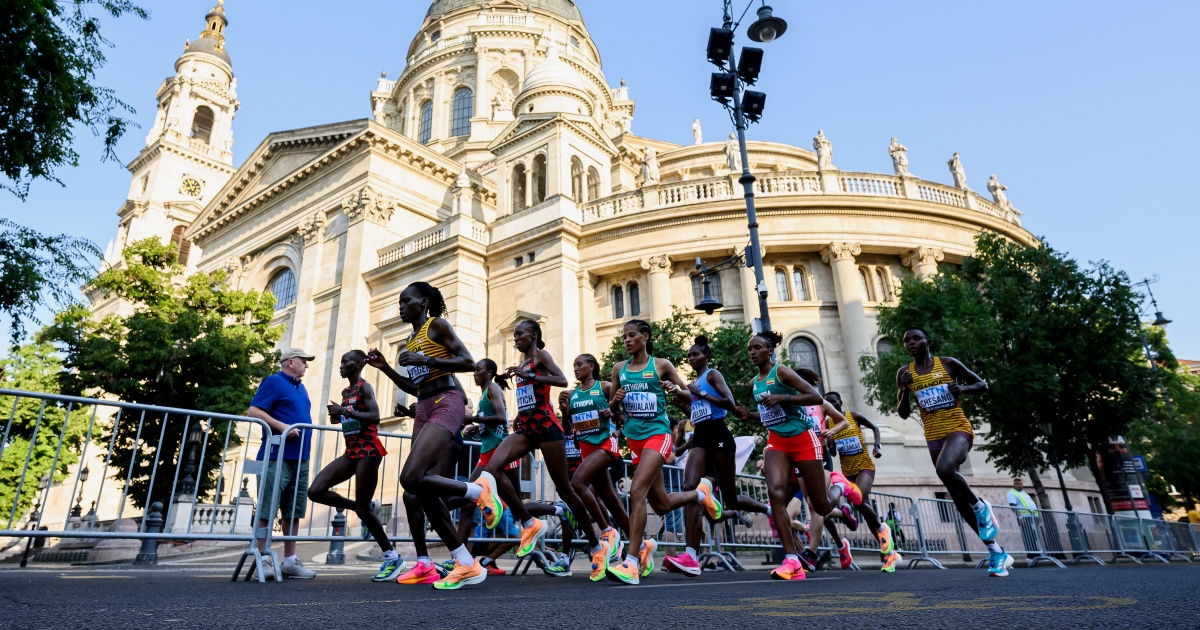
[0,0,150,199]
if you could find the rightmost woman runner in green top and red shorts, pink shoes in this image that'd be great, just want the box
[738,331,833,580]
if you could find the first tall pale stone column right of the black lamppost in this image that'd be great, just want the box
[821,242,875,412]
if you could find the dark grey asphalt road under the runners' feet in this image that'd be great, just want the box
[0,563,1200,630]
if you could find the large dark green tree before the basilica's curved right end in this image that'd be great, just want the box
[860,232,1154,511]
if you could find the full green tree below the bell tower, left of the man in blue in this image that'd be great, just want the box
[41,238,282,505]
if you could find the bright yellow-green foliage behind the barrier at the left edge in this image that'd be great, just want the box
[0,343,91,523]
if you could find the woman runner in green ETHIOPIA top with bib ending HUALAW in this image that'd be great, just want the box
[608,319,721,584]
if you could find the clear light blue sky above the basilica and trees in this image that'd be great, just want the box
[0,0,1200,359]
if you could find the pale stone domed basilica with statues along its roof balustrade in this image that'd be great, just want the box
[95,0,1094,505]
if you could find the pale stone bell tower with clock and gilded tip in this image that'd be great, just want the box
[104,0,240,272]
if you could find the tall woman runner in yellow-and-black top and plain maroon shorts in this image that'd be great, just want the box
[367,282,482,589]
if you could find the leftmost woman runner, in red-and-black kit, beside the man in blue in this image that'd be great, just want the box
[308,350,404,582]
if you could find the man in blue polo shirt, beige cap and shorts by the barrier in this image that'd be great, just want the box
[246,348,317,580]
